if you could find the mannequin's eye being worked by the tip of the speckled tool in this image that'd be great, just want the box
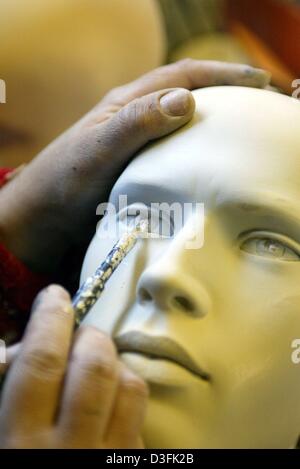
[118,206,174,238]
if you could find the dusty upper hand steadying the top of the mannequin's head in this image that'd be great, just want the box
[0,59,269,273]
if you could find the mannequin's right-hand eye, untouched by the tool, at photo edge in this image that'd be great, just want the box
[240,232,300,261]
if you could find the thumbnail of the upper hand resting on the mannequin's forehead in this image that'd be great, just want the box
[160,89,193,116]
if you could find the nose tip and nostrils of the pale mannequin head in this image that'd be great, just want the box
[137,261,211,317]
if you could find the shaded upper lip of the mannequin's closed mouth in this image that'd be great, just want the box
[114,331,210,381]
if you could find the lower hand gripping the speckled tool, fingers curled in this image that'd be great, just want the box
[0,285,148,448]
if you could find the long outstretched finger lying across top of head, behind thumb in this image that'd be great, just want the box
[101,59,270,106]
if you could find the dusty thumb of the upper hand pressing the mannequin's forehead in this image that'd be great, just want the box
[94,88,195,167]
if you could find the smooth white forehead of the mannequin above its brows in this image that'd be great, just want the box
[112,87,300,204]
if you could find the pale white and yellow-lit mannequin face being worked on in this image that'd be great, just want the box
[81,87,300,448]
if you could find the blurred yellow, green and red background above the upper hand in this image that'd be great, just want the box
[0,0,300,167]
